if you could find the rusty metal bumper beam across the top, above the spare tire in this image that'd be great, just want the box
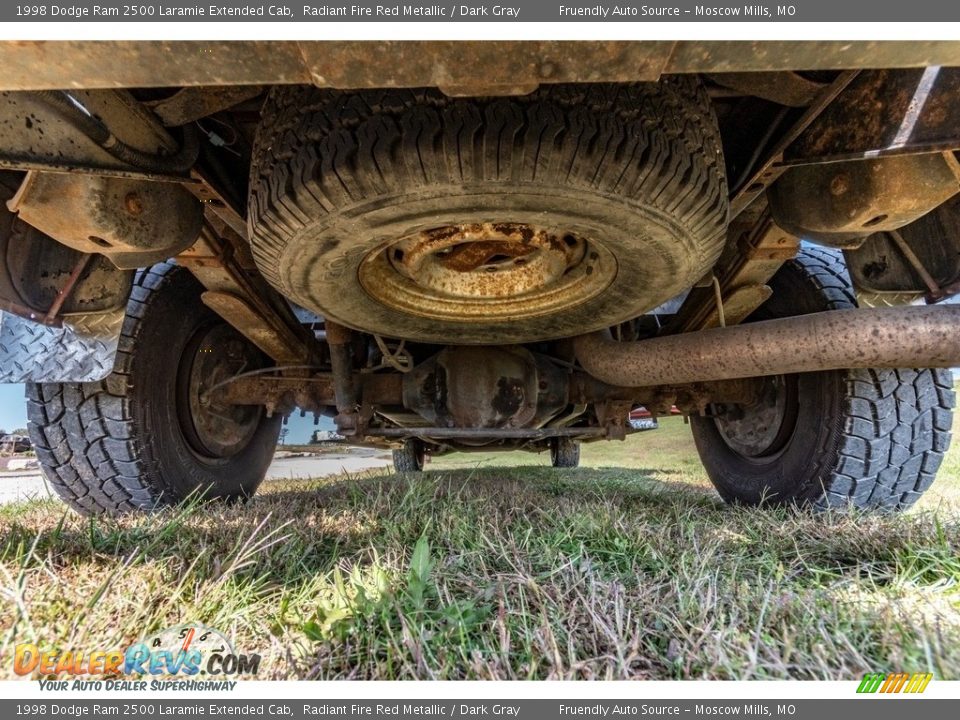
[0,41,960,94]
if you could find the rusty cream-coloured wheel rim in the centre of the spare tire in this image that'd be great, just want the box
[359,223,617,322]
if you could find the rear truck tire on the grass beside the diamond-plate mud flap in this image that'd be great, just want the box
[26,264,281,515]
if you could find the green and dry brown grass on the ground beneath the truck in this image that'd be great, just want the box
[0,419,960,679]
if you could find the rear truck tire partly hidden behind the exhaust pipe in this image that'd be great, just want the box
[691,248,955,510]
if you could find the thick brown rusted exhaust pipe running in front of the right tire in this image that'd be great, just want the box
[574,305,960,387]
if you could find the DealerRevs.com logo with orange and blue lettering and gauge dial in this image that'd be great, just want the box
[13,623,260,678]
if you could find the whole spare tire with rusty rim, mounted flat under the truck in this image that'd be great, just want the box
[249,76,727,344]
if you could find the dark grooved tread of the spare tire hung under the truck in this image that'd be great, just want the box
[249,77,727,304]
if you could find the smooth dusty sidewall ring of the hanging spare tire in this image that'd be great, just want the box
[280,182,706,343]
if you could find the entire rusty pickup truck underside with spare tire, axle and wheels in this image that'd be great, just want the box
[0,42,960,513]
